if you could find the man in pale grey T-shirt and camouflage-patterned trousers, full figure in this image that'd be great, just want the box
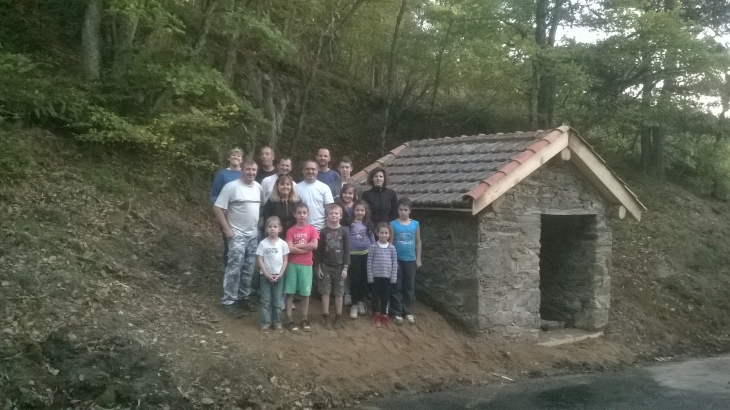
[213,160,264,317]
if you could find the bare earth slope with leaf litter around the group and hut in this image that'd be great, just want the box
[0,130,730,409]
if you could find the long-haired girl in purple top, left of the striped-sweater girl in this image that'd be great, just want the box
[348,201,375,319]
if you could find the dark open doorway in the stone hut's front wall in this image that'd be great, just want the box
[540,215,598,327]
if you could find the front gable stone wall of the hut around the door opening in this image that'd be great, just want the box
[477,156,611,339]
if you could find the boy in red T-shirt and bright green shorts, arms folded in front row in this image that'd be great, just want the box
[284,203,319,332]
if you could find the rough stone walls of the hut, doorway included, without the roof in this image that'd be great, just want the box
[413,156,612,340]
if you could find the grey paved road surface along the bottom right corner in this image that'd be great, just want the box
[358,356,730,410]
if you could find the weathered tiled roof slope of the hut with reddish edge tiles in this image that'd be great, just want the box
[355,131,561,208]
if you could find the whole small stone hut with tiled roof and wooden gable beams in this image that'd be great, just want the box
[354,126,646,340]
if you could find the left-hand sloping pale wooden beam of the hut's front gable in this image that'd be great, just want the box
[471,131,570,215]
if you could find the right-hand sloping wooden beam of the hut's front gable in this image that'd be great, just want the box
[568,135,646,222]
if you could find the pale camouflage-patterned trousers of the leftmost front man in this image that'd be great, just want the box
[221,234,258,305]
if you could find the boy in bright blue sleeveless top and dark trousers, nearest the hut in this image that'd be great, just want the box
[390,198,421,326]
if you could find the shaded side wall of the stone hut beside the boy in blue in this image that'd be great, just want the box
[411,209,479,329]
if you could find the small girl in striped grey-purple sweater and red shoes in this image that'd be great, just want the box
[368,222,398,329]
